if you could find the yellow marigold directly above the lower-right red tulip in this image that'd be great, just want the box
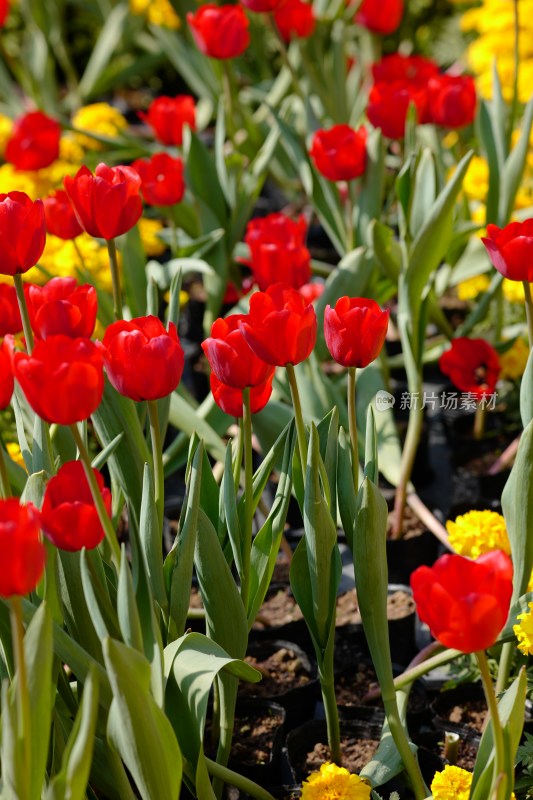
[446,511,511,558]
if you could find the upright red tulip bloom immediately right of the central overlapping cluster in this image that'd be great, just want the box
[324,297,390,367]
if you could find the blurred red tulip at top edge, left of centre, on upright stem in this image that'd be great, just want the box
[187,3,250,59]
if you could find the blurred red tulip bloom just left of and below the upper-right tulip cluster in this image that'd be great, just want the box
[309,125,367,181]
